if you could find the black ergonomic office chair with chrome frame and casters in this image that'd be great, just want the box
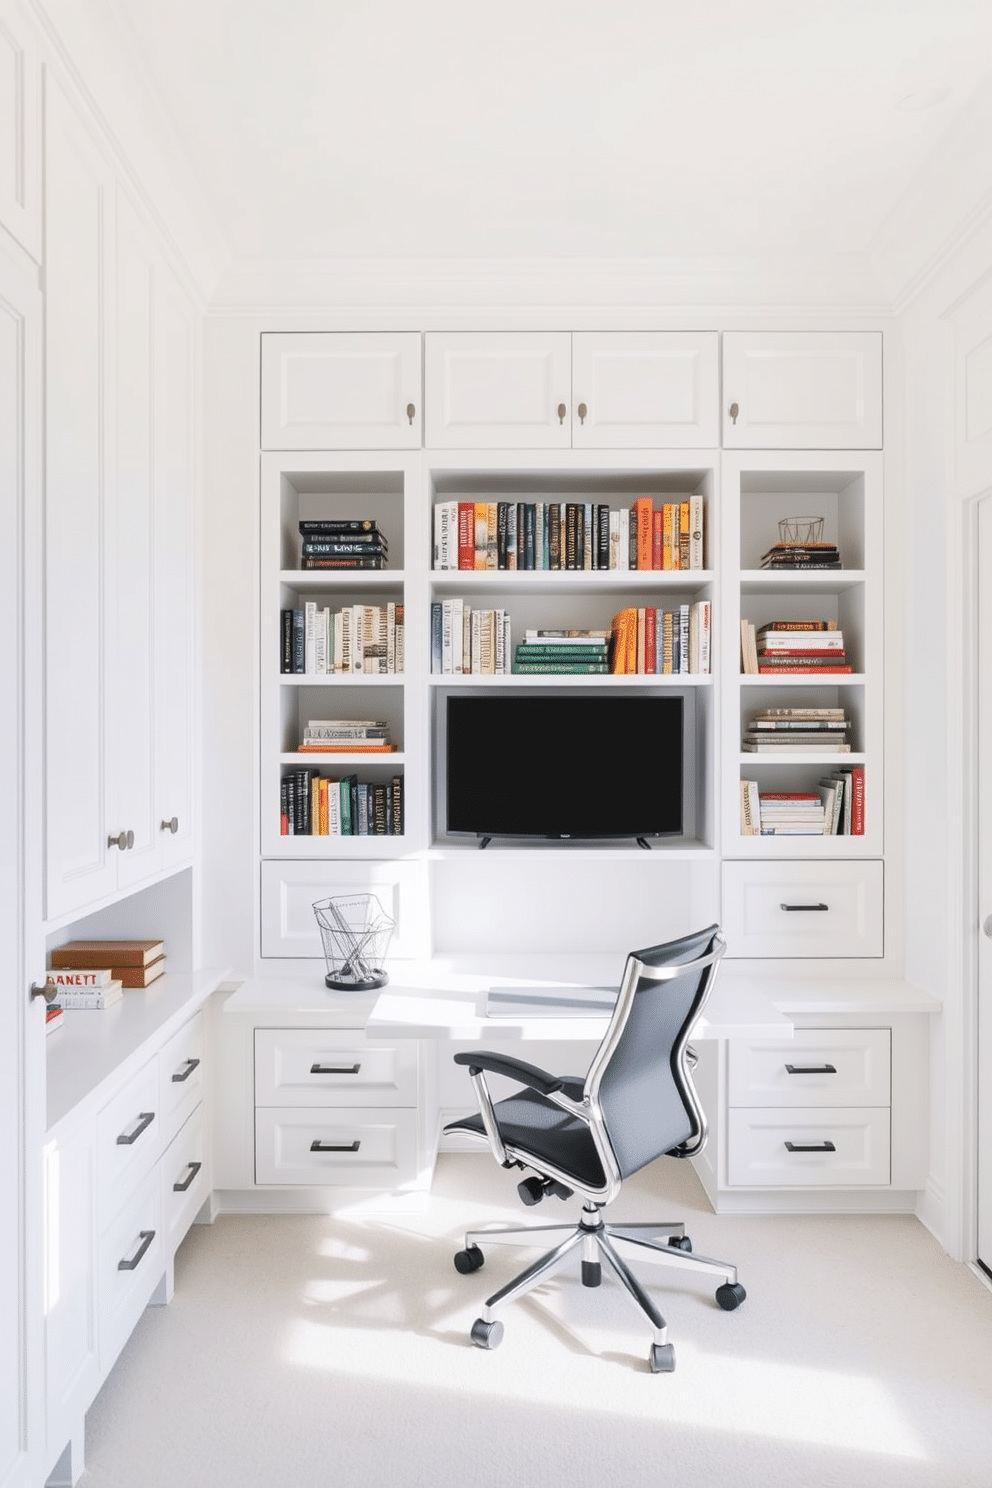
[445,926,747,1373]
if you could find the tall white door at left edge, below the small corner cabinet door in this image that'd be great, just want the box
[0,241,45,1488]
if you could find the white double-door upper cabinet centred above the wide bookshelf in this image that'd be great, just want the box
[424,330,718,449]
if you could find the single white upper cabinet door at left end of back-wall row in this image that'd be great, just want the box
[262,330,422,449]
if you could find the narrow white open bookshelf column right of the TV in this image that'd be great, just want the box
[721,454,883,859]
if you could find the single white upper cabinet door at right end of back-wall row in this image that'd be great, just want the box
[723,330,882,449]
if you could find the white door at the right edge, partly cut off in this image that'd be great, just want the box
[977,496,992,1274]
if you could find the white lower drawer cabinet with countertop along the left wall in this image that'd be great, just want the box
[45,973,219,1484]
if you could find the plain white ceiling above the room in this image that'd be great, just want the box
[113,0,992,276]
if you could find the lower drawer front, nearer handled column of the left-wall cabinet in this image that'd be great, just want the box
[97,1171,165,1373]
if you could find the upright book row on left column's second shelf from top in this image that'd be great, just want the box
[280,600,405,677]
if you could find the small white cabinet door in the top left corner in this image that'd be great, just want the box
[0,0,42,263]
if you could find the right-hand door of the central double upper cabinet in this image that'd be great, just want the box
[571,330,720,449]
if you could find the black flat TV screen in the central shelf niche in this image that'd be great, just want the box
[445,692,683,839]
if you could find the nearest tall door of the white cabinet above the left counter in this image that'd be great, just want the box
[45,82,120,918]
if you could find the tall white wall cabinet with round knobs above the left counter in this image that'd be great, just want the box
[45,79,196,920]
